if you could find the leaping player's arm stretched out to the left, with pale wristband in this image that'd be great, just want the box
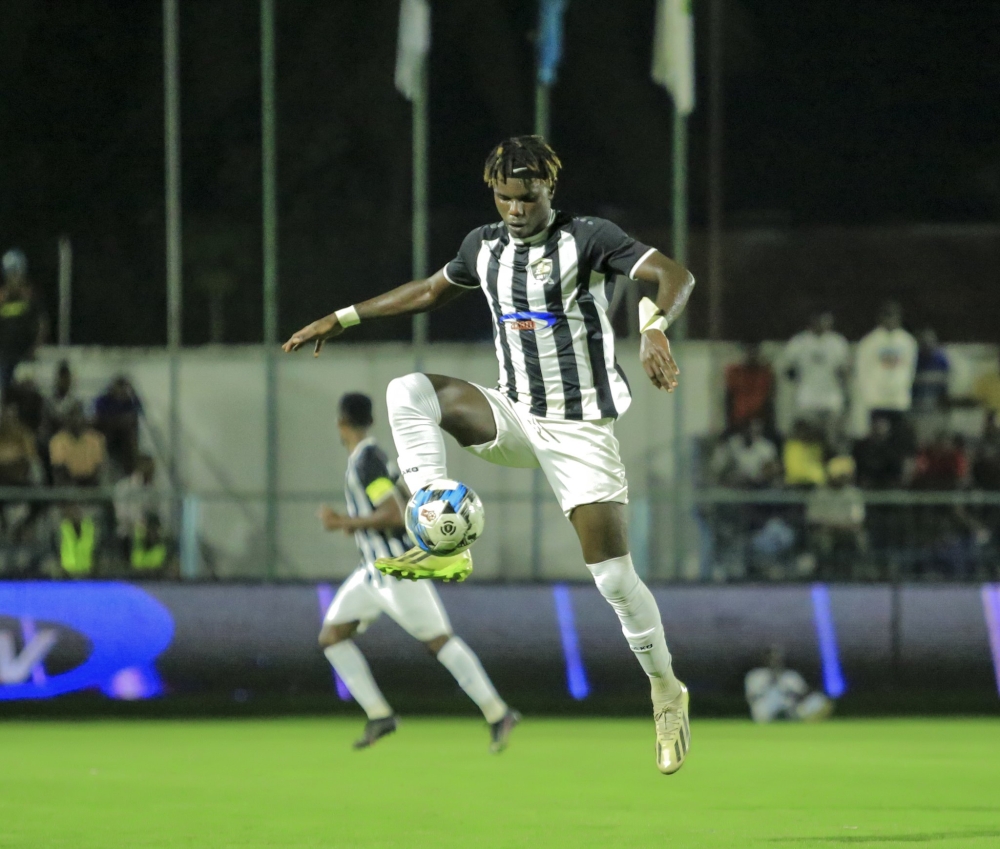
[281,269,466,357]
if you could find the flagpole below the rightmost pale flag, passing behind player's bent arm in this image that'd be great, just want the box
[671,105,691,578]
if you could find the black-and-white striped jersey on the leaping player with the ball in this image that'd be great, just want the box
[444,213,654,421]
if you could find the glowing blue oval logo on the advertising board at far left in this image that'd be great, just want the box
[0,581,174,701]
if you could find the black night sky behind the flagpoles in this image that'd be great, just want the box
[0,0,1000,344]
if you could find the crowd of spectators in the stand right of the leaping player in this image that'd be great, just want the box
[707,303,1000,578]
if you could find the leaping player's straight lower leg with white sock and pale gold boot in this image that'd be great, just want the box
[570,502,691,775]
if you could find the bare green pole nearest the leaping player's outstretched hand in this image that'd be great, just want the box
[260,0,278,579]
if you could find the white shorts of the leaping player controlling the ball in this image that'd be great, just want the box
[466,383,628,516]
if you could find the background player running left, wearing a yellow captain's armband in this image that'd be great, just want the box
[319,392,520,752]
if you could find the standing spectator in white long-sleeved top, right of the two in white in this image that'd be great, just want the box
[855,302,917,432]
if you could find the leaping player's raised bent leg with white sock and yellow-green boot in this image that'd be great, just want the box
[375,374,497,580]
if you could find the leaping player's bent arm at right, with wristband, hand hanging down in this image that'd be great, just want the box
[635,251,694,392]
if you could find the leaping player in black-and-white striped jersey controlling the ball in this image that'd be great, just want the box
[284,136,694,774]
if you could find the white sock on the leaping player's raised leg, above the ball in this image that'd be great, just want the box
[385,374,448,492]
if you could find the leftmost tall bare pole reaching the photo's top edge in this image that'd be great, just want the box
[163,0,183,496]
